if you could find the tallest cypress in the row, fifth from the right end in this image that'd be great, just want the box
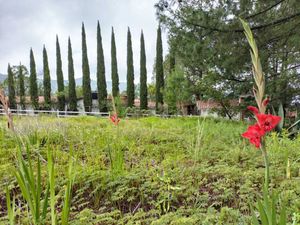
[97,21,107,112]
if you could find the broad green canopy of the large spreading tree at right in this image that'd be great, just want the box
[156,0,300,109]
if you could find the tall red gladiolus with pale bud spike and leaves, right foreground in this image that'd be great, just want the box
[241,19,287,225]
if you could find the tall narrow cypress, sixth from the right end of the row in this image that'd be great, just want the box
[81,23,92,112]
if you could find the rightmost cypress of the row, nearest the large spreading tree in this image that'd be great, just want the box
[155,25,164,111]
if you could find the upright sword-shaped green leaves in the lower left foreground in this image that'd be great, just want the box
[6,145,74,225]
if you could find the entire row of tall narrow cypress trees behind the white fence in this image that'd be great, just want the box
[8,21,164,112]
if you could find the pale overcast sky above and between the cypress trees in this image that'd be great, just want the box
[0,0,168,83]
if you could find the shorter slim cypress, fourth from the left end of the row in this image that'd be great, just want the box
[43,45,51,109]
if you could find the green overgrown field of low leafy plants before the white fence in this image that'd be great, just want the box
[0,117,300,225]
